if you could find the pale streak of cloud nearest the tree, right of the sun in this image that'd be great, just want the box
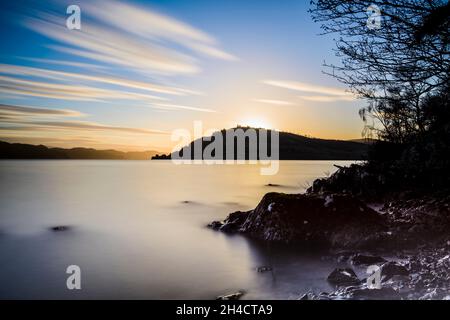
[263,80,355,102]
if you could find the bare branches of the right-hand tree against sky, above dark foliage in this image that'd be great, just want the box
[310,0,450,143]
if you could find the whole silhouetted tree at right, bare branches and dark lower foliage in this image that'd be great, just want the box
[310,0,450,188]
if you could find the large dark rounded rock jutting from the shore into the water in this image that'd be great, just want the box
[213,193,385,248]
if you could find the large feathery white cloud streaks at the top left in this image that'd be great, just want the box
[25,1,237,75]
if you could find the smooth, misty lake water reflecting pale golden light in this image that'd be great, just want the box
[0,161,348,299]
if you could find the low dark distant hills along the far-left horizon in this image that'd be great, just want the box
[0,141,157,160]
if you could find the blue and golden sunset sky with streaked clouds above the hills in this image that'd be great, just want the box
[0,0,364,152]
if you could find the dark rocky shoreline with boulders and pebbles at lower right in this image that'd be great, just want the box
[209,168,450,300]
